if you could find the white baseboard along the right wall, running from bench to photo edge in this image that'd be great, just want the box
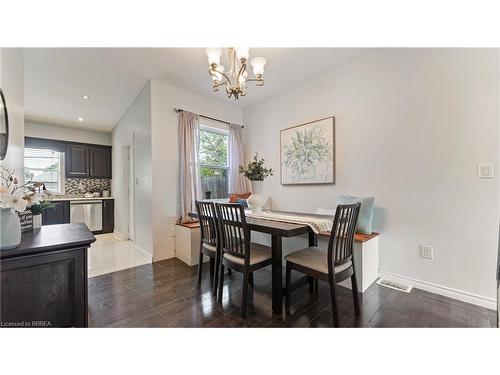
[379,272,497,311]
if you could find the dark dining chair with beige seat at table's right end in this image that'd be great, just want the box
[285,203,361,327]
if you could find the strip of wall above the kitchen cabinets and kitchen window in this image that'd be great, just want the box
[24,119,111,145]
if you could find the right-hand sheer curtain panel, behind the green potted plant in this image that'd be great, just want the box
[229,124,250,194]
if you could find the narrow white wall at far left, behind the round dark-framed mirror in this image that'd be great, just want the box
[0,48,24,180]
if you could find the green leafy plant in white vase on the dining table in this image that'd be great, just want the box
[240,153,274,214]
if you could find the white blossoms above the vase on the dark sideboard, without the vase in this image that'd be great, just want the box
[0,166,45,212]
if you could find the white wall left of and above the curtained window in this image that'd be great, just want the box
[151,80,243,260]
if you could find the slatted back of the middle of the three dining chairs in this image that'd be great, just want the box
[215,203,250,265]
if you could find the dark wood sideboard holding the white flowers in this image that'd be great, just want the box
[0,224,96,327]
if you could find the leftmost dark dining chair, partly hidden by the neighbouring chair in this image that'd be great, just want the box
[195,201,220,296]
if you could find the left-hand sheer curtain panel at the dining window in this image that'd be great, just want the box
[179,111,201,223]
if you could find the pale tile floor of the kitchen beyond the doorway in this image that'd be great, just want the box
[88,233,151,278]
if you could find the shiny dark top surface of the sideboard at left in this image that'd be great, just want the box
[0,223,96,259]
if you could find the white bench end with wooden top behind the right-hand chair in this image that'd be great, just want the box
[319,232,380,293]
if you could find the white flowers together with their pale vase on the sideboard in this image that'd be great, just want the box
[0,166,43,250]
